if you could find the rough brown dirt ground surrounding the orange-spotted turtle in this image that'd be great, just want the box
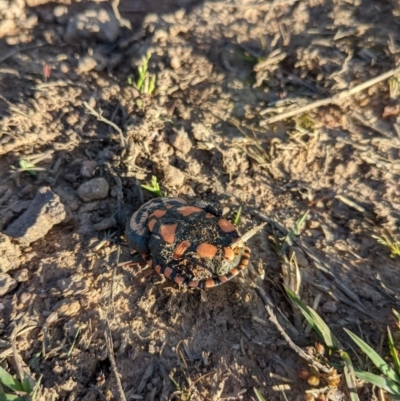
[0,0,400,401]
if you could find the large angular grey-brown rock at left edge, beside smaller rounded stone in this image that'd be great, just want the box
[5,187,67,244]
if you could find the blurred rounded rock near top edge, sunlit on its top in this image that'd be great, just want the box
[64,8,120,43]
